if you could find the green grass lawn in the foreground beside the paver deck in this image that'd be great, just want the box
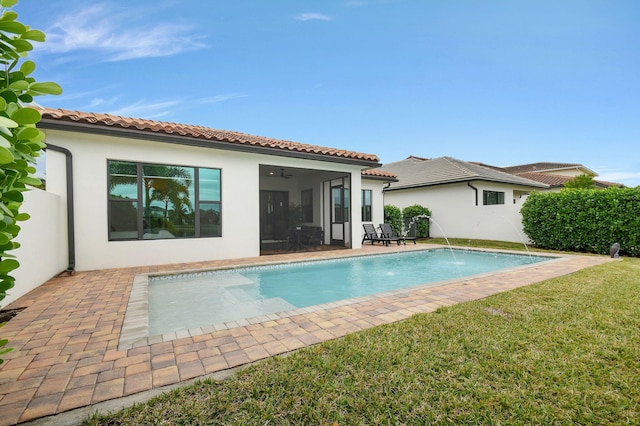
[86,246,640,425]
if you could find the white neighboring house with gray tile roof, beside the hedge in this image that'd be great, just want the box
[379,156,548,242]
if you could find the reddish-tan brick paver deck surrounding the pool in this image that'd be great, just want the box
[0,244,612,425]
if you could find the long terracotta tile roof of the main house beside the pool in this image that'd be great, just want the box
[41,108,379,163]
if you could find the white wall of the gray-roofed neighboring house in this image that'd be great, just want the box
[384,181,527,242]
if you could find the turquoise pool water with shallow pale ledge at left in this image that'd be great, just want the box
[149,249,549,335]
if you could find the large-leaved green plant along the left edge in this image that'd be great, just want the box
[0,0,62,364]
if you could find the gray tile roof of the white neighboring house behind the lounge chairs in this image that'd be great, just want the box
[381,156,548,190]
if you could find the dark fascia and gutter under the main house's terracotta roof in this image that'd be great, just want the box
[38,118,381,168]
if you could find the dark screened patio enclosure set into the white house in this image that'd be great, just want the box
[260,164,352,253]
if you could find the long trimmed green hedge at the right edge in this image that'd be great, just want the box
[521,187,640,256]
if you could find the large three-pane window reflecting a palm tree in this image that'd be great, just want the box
[108,160,222,240]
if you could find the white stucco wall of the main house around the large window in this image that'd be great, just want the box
[45,129,361,271]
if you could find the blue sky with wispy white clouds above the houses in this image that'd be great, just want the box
[14,0,640,186]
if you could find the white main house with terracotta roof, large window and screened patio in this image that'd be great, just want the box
[5,109,394,303]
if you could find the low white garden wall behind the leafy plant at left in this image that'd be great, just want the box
[7,189,68,307]
